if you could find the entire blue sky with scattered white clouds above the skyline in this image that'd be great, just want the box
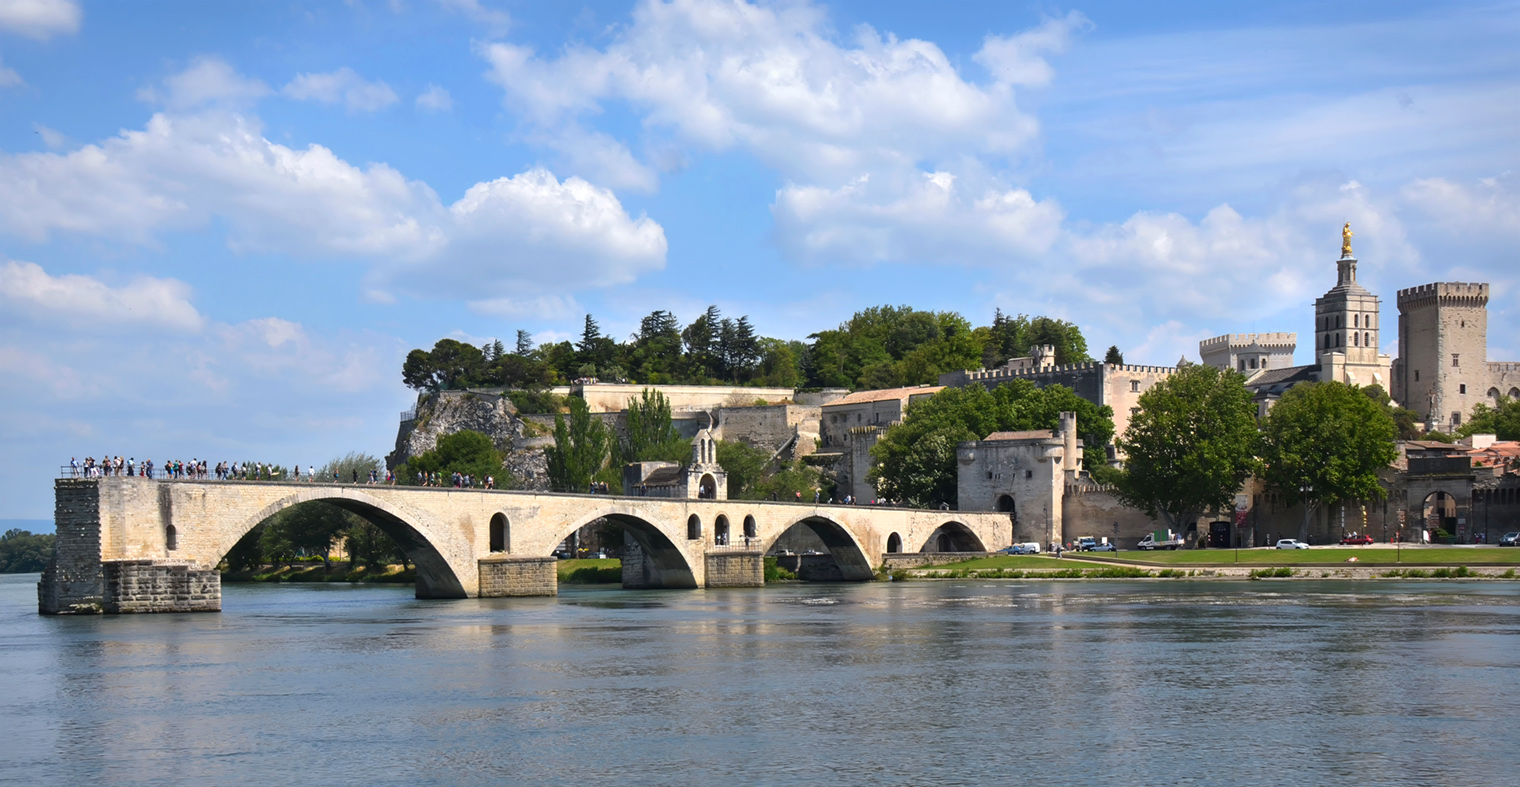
[0,0,1520,518]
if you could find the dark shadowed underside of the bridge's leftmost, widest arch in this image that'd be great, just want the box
[216,486,470,599]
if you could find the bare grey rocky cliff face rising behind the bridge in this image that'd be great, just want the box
[386,390,553,491]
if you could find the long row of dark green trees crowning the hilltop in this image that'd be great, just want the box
[401,305,1091,390]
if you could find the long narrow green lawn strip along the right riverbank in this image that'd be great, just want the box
[1082,547,1520,565]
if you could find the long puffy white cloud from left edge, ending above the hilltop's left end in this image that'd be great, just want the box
[0,60,667,301]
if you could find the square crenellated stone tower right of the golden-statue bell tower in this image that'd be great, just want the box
[1391,281,1496,431]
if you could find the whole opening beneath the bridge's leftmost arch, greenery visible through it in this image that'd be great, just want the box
[220,495,468,599]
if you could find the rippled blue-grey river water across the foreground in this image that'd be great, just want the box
[0,574,1520,785]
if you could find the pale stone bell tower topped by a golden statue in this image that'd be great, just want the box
[1315,225,1392,390]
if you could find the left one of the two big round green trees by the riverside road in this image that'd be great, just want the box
[1116,365,1260,543]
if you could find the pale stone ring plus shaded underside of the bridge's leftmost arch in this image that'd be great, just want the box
[211,486,476,599]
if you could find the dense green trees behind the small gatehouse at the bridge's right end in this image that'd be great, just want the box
[869,380,1114,507]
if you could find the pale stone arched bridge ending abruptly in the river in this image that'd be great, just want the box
[38,477,1012,614]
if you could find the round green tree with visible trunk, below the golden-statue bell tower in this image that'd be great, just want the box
[1263,381,1398,538]
